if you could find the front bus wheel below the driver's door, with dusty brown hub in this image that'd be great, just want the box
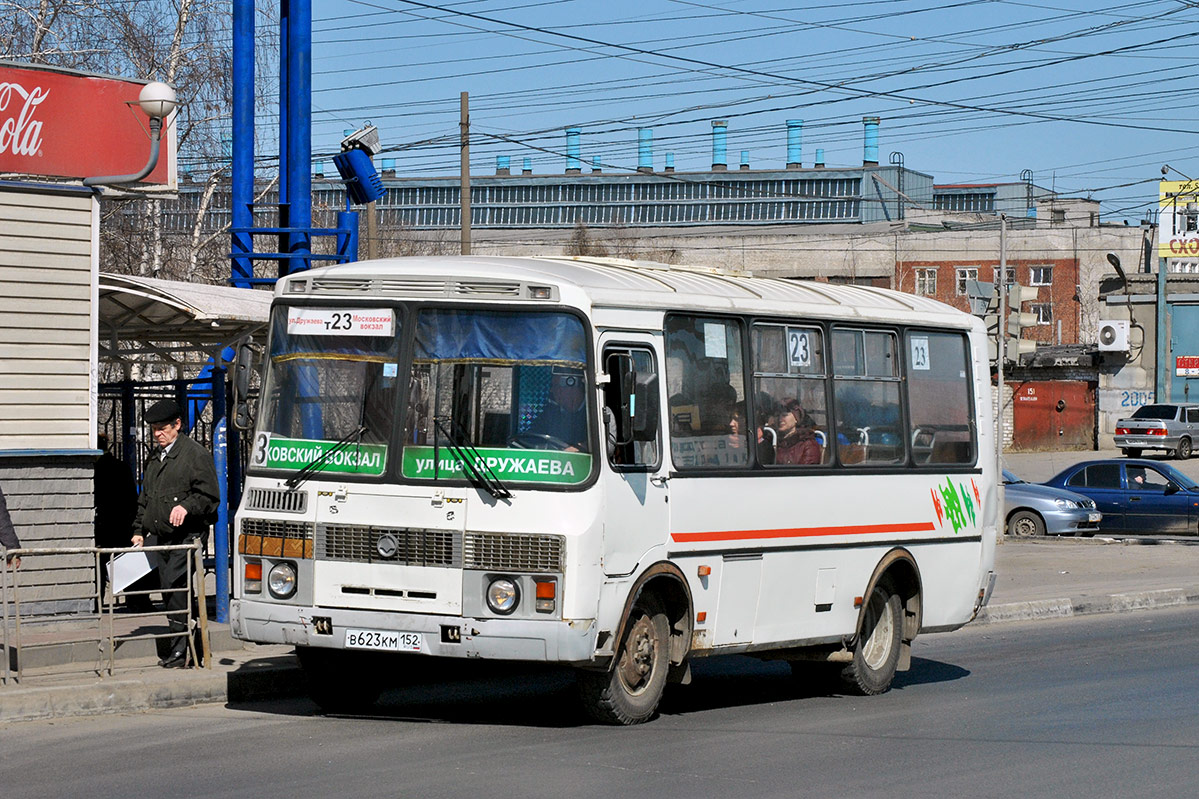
[578,594,670,725]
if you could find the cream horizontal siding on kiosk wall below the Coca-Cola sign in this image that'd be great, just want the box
[0,188,97,452]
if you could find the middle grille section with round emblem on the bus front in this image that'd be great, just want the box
[317,524,462,567]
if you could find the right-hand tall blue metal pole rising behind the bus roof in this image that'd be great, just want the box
[287,0,312,272]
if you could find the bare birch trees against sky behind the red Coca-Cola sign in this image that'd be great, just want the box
[0,0,278,282]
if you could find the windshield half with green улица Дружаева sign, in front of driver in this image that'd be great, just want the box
[402,310,594,486]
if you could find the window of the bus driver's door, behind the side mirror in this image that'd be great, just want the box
[602,347,659,469]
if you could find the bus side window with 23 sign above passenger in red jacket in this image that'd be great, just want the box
[752,324,831,465]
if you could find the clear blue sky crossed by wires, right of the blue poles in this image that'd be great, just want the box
[292,0,1199,223]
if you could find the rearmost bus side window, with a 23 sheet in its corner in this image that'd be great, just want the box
[905,331,975,464]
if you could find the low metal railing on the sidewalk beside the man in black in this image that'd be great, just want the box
[0,540,212,684]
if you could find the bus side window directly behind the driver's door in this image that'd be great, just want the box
[665,316,749,469]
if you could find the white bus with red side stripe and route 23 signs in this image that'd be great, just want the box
[230,257,999,723]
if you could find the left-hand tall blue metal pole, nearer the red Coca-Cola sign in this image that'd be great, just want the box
[230,0,254,288]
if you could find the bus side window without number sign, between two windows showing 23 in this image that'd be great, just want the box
[832,328,905,464]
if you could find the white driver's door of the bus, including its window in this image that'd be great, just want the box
[601,332,669,575]
